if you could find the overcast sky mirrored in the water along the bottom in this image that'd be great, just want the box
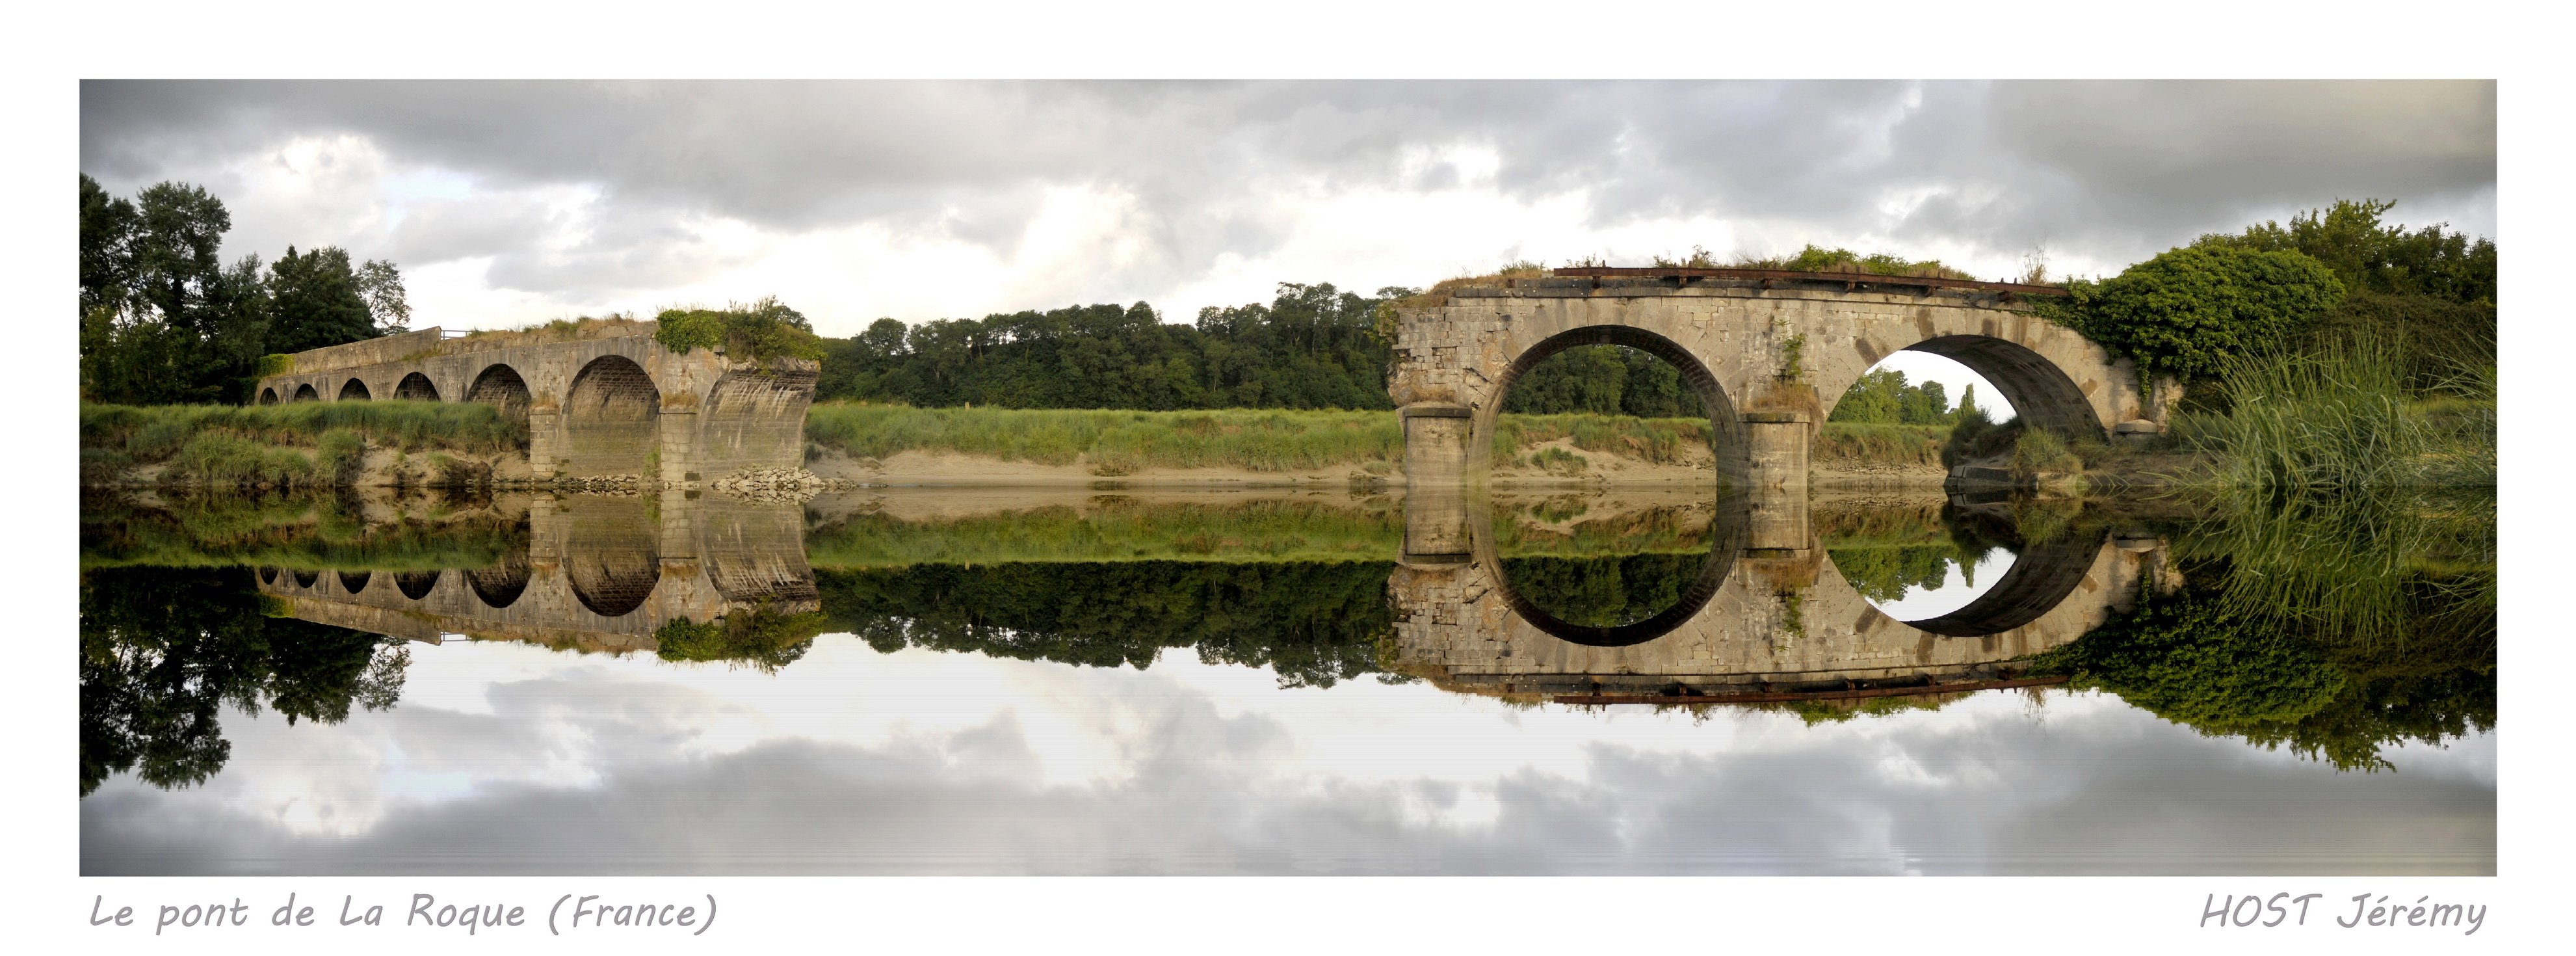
[80,634,2496,876]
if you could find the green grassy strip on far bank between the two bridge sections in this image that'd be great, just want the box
[806,402,1404,477]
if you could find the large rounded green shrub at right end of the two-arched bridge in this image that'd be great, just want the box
[2040,245,2344,378]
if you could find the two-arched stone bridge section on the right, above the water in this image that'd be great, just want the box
[1389,268,2177,487]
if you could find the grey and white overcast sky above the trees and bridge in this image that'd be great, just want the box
[80,80,2496,345]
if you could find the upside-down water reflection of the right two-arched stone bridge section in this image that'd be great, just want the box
[1389,487,2177,704]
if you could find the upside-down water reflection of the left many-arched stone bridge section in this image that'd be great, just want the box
[260,490,819,652]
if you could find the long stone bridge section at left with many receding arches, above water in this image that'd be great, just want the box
[257,319,819,485]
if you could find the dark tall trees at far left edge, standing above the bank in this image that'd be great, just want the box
[80,172,412,405]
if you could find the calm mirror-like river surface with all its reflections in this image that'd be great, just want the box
[80,490,2496,873]
